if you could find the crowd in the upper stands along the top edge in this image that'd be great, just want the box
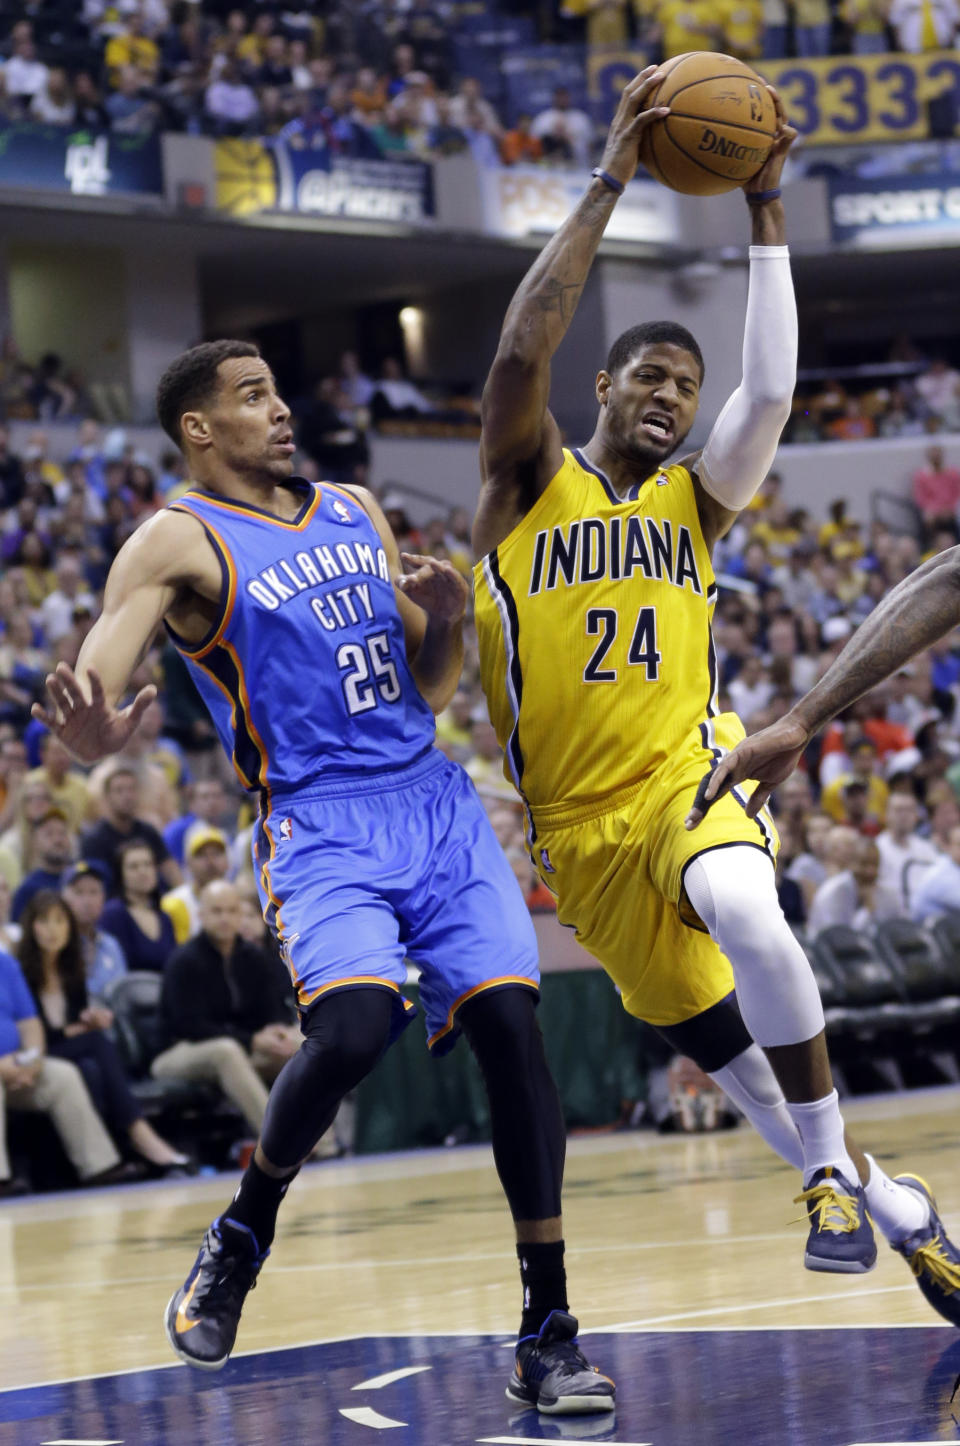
[0,0,960,175]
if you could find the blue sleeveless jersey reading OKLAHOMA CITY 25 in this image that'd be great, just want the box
[164,479,434,792]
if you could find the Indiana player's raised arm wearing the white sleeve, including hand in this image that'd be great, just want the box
[695,85,797,547]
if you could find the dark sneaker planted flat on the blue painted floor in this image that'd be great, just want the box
[506,1310,617,1416]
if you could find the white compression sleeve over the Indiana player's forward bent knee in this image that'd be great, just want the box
[684,843,824,1048]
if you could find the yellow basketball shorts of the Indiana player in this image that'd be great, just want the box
[533,713,779,1025]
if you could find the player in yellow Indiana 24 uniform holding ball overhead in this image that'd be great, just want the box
[474,68,948,1314]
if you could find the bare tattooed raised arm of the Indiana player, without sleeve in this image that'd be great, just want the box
[474,65,668,552]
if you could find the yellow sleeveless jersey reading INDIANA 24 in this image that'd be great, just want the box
[474,450,717,827]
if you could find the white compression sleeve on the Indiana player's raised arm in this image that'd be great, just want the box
[697,246,797,512]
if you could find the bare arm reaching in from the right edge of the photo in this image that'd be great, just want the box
[687,547,960,829]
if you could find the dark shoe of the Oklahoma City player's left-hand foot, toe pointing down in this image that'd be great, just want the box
[163,1216,264,1371]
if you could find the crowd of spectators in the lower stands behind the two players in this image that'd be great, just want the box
[0,396,960,1194]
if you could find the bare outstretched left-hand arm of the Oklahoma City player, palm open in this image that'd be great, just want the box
[33,512,217,763]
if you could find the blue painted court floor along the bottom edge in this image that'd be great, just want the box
[0,1327,960,1446]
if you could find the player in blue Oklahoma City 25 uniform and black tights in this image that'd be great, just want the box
[36,341,614,1414]
